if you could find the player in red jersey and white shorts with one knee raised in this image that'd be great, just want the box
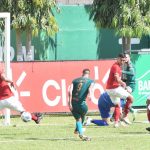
[106,54,133,127]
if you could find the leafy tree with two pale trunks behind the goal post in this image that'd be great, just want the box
[0,0,58,61]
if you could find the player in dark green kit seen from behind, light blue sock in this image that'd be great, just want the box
[68,69,94,141]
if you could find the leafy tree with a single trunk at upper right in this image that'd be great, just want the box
[90,0,150,51]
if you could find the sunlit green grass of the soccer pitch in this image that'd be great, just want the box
[0,113,150,150]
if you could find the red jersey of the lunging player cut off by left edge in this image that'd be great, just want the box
[0,71,13,100]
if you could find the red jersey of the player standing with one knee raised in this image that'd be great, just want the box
[106,62,122,89]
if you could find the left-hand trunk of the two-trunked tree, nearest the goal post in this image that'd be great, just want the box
[16,29,23,61]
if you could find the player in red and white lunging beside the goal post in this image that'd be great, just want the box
[0,70,42,124]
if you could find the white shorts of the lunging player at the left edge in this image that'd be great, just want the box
[0,96,25,112]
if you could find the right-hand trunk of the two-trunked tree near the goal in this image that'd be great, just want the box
[26,28,33,61]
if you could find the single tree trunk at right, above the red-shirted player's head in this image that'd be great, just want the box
[122,37,131,53]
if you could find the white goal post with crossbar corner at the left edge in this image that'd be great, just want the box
[0,12,12,125]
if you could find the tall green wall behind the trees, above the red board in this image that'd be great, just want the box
[8,2,150,61]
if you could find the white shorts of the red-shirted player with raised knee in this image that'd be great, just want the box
[106,86,130,104]
